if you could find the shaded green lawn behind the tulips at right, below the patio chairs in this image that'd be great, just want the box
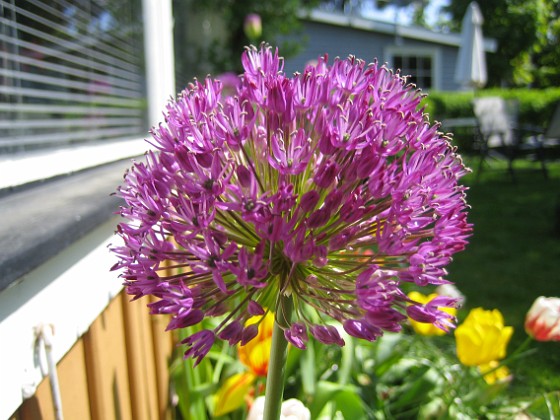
[449,157,560,396]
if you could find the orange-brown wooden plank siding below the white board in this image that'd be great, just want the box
[12,292,174,420]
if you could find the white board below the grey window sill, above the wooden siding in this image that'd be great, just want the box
[0,218,123,419]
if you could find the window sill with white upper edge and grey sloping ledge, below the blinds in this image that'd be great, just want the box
[0,141,147,292]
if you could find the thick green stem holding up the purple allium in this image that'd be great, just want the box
[263,295,293,420]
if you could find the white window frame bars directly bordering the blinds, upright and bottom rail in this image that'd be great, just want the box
[0,0,176,190]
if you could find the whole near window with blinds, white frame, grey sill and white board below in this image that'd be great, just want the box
[0,0,175,418]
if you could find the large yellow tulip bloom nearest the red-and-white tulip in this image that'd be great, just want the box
[455,308,513,366]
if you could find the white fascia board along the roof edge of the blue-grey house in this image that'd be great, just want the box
[300,9,497,52]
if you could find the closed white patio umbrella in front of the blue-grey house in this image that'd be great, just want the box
[455,1,487,89]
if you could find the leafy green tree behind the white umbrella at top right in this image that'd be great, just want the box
[445,0,560,87]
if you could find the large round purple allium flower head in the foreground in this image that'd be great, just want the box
[114,46,471,361]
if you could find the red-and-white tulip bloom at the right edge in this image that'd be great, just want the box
[525,296,560,341]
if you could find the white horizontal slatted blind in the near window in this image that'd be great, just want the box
[0,0,146,153]
